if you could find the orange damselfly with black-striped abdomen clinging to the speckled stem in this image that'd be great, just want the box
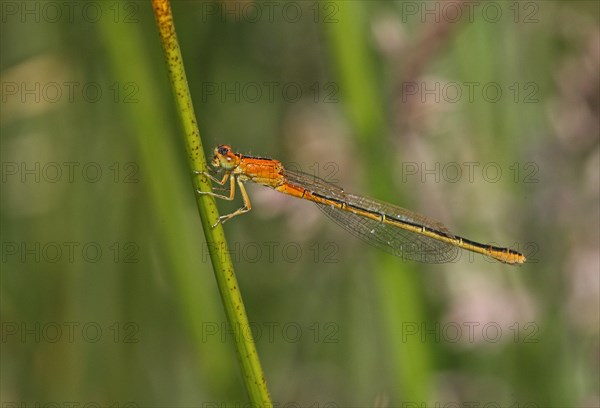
[195,145,525,264]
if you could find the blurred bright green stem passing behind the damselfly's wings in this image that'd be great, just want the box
[326,1,431,401]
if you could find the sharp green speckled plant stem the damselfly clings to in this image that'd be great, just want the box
[152,0,272,407]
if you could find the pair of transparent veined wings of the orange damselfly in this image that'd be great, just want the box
[284,170,459,263]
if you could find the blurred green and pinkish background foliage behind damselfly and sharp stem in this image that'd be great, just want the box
[0,1,600,407]
